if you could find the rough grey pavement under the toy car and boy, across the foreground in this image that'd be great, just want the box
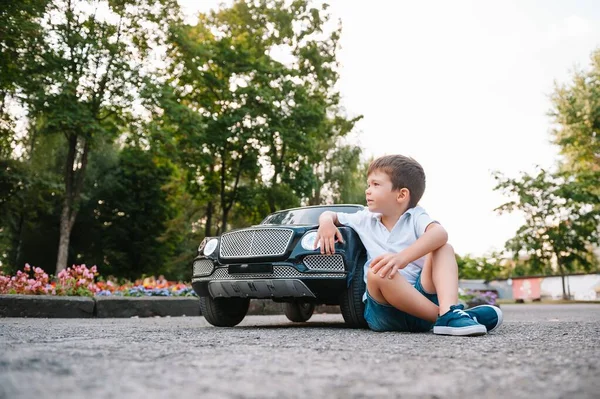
[0,304,600,399]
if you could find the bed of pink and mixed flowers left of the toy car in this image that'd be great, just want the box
[0,264,196,297]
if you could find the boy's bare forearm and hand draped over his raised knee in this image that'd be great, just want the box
[371,223,448,278]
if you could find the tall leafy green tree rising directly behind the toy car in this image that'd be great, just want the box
[154,0,358,236]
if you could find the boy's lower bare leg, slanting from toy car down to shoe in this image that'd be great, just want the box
[367,269,438,322]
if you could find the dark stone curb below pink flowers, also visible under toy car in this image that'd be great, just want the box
[0,295,340,318]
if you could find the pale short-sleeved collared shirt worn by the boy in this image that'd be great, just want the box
[337,206,436,300]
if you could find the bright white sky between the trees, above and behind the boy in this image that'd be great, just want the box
[179,0,600,256]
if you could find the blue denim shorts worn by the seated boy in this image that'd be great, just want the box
[365,274,439,332]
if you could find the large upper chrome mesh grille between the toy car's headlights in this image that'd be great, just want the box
[219,229,294,258]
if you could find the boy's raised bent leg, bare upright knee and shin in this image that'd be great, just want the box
[418,244,458,315]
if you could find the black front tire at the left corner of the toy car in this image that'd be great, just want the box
[200,296,250,327]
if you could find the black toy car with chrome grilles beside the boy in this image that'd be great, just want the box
[192,205,366,327]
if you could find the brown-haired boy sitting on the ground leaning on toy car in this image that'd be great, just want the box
[316,155,502,335]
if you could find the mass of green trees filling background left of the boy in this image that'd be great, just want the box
[0,0,365,280]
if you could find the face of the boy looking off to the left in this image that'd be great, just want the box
[365,170,409,215]
